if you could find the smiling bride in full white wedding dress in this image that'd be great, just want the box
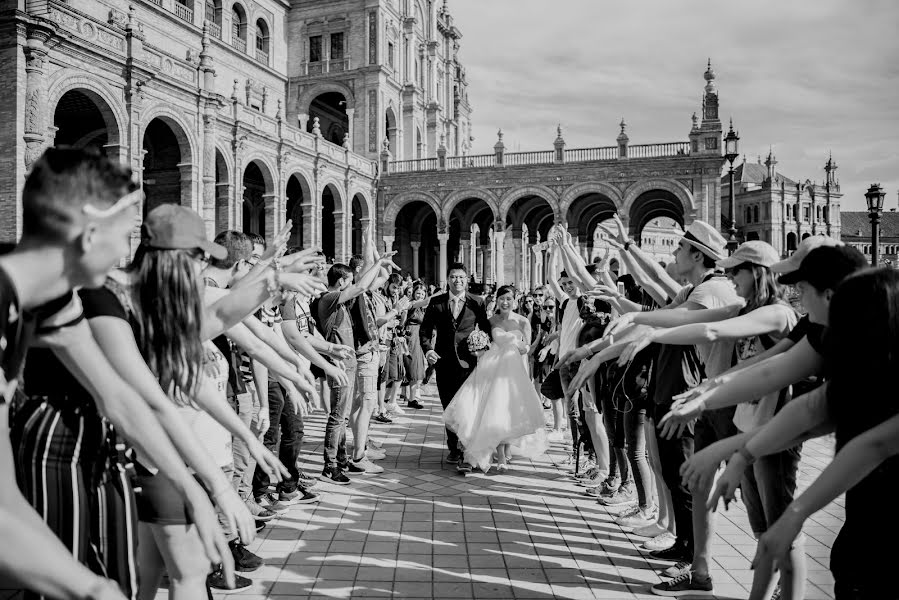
[443,285,547,472]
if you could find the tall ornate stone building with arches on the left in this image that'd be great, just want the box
[0,0,470,258]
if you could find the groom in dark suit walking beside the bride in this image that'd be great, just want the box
[419,263,491,470]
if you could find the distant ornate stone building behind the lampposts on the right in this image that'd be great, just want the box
[721,152,843,255]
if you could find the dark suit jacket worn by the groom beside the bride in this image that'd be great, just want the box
[419,292,492,371]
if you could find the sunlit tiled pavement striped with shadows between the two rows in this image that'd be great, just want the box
[0,386,843,600]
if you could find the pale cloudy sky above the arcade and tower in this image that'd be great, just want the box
[448,0,899,210]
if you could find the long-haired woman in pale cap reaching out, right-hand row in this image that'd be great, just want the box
[619,241,805,598]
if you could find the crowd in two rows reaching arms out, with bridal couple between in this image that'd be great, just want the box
[0,148,899,600]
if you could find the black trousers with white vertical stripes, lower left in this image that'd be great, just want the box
[10,396,138,599]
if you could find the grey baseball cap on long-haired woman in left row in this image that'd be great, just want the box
[143,204,228,260]
